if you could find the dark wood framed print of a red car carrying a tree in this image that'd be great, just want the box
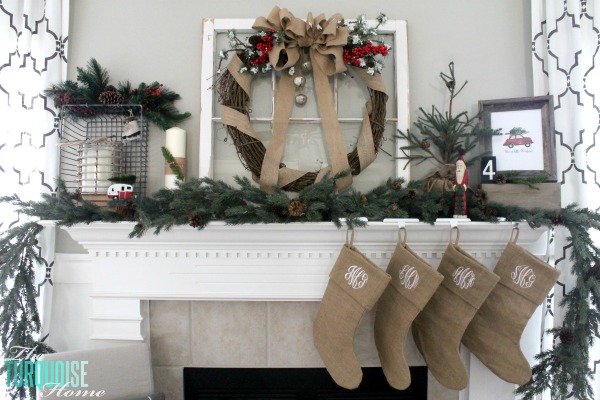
[479,96,556,182]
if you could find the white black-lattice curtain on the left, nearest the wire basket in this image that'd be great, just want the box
[0,0,69,362]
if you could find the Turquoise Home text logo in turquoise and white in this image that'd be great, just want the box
[4,347,105,397]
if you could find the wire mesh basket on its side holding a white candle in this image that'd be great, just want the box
[59,104,148,205]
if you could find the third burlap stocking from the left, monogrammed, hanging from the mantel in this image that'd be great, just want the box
[412,244,500,390]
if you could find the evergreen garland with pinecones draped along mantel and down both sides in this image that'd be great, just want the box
[0,176,600,400]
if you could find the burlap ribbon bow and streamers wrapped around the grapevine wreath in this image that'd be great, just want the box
[221,7,386,191]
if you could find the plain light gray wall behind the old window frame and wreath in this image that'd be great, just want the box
[68,0,533,192]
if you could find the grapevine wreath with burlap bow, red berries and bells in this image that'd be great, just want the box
[216,7,389,192]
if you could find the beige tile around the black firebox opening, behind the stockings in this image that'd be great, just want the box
[150,301,459,400]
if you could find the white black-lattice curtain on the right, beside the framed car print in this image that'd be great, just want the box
[532,0,600,394]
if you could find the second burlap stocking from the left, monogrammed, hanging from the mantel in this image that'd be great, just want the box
[375,239,444,390]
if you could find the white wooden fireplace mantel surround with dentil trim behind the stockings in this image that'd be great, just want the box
[58,220,548,399]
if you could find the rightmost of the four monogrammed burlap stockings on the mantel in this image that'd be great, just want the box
[462,238,559,385]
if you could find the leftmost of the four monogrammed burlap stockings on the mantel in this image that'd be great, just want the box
[313,244,390,389]
